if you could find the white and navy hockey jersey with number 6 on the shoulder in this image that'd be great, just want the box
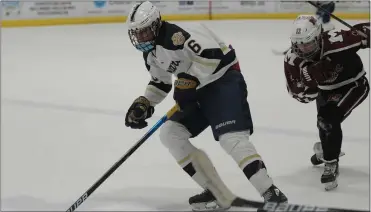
[143,21,238,106]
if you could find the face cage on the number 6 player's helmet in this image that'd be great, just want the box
[128,18,161,52]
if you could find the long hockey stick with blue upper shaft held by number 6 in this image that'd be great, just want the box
[66,105,178,212]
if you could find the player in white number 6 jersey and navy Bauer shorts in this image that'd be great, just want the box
[125,1,287,210]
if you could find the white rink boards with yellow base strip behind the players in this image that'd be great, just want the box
[0,0,370,27]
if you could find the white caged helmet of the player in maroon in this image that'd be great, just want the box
[290,15,322,59]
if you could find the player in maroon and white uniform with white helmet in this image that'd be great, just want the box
[284,15,370,190]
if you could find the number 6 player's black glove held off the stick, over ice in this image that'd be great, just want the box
[125,96,155,129]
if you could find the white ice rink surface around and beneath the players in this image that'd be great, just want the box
[1,20,370,211]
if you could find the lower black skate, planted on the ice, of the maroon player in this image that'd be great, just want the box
[321,160,339,191]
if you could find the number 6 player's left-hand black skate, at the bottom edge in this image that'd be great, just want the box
[189,190,229,211]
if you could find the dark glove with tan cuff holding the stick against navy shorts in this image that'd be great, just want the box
[173,73,200,110]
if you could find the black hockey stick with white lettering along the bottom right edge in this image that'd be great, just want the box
[232,197,367,212]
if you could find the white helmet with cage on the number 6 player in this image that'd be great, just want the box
[126,1,161,52]
